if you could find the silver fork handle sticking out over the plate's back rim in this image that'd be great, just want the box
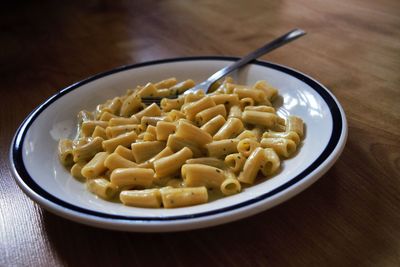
[204,29,306,93]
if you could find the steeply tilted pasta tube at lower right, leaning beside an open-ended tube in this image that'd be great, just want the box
[238,147,265,184]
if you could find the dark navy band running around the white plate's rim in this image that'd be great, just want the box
[10,56,345,222]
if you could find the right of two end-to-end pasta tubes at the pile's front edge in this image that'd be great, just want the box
[160,186,208,208]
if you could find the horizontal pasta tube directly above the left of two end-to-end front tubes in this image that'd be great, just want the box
[110,168,154,188]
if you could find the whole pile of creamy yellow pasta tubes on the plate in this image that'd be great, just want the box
[58,78,303,208]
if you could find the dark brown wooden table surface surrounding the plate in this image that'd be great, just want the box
[0,0,400,266]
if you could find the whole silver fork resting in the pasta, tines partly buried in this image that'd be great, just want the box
[142,29,306,105]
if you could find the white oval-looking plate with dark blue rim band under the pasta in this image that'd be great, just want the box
[10,57,347,232]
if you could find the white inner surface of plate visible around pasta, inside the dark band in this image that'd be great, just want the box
[22,59,333,218]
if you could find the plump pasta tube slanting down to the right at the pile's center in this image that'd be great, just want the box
[175,121,213,146]
